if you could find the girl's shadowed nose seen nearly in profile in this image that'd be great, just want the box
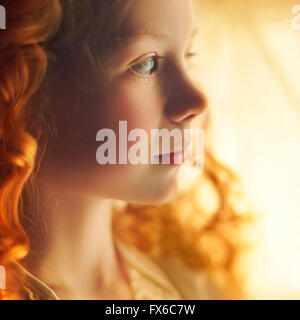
[165,70,208,125]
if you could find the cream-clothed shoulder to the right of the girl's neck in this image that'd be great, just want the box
[117,240,221,300]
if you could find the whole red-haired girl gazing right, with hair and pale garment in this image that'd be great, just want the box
[0,0,248,299]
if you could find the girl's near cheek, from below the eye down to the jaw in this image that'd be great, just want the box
[40,76,171,198]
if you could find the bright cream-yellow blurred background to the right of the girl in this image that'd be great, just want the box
[190,0,300,299]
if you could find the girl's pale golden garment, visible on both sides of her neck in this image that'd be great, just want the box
[9,239,217,300]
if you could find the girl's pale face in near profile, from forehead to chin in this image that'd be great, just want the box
[40,0,205,204]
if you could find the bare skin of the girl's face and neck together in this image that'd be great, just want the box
[27,0,206,299]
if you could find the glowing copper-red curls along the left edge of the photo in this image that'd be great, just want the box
[0,0,60,299]
